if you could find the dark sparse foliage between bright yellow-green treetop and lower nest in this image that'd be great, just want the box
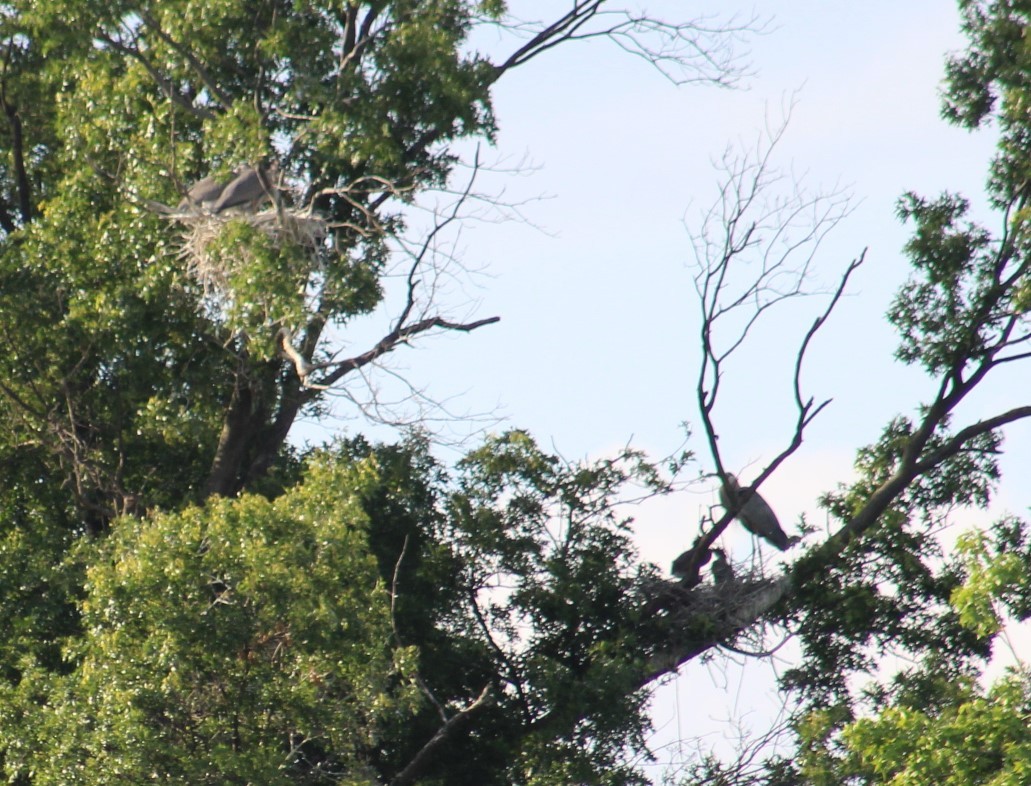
[368,431,663,784]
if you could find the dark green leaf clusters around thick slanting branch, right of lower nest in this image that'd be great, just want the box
[785,418,998,709]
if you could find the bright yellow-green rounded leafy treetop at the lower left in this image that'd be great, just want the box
[3,449,414,784]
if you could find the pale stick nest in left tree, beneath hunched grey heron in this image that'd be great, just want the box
[168,205,329,297]
